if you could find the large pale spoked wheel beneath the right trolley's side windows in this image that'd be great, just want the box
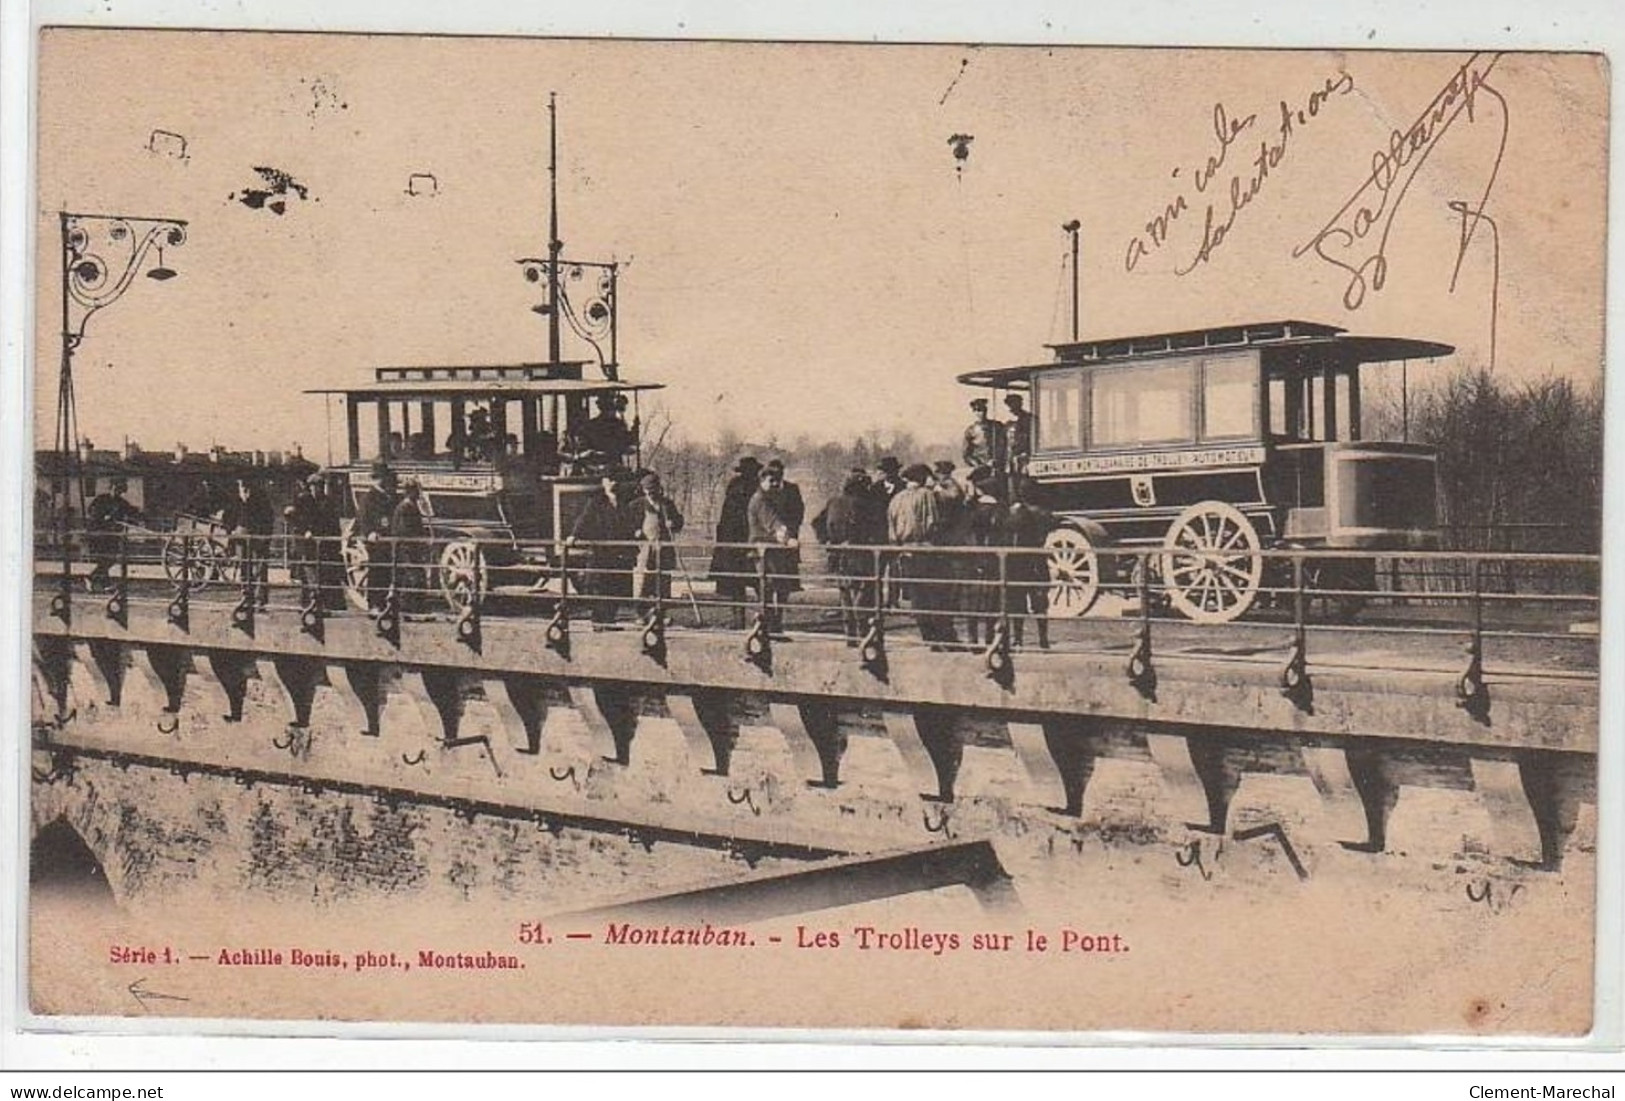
[1162,500,1264,624]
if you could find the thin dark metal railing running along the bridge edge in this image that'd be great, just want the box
[36,529,1601,697]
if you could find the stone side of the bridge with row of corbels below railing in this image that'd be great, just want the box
[36,565,1596,867]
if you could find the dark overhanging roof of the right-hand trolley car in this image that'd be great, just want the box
[959,322,1456,390]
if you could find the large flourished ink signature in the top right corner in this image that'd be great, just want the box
[1292,54,1510,310]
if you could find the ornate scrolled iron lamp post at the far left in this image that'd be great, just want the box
[57,211,187,615]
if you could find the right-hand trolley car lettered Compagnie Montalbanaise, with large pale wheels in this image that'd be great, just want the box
[959,322,1454,622]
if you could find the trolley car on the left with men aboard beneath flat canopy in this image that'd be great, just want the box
[307,362,661,612]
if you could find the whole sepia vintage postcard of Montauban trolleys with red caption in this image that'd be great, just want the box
[26,28,1619,1038]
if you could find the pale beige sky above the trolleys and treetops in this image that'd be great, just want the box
[34,29,1607,460]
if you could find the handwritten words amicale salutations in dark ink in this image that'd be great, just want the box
[1123,73,1354,276]
